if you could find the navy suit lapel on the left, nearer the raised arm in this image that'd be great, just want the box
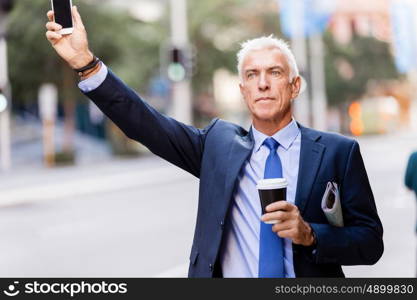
[224,129,254,207]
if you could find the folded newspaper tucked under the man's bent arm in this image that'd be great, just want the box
[321,181,343,227]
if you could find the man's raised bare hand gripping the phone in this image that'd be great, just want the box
[46,5,94,69]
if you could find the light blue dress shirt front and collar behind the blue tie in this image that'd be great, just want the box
[220,119,301,278]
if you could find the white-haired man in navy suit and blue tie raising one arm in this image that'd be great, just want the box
[46,7,383,277]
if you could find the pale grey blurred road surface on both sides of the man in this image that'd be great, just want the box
[0,129,417,277]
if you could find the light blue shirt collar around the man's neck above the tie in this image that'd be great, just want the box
[252,119,300,152]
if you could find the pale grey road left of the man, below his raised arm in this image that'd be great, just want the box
[0,158,198,277]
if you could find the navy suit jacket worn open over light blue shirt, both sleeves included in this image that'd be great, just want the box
[86,71,384,277]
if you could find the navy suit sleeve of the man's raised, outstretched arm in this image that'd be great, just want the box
[85,70,217,177]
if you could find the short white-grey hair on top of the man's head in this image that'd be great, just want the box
[237,34,299,81]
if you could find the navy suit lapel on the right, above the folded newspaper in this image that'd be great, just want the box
[295,125,326,214]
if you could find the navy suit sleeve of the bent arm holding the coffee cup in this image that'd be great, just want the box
[310,141,384,265]
